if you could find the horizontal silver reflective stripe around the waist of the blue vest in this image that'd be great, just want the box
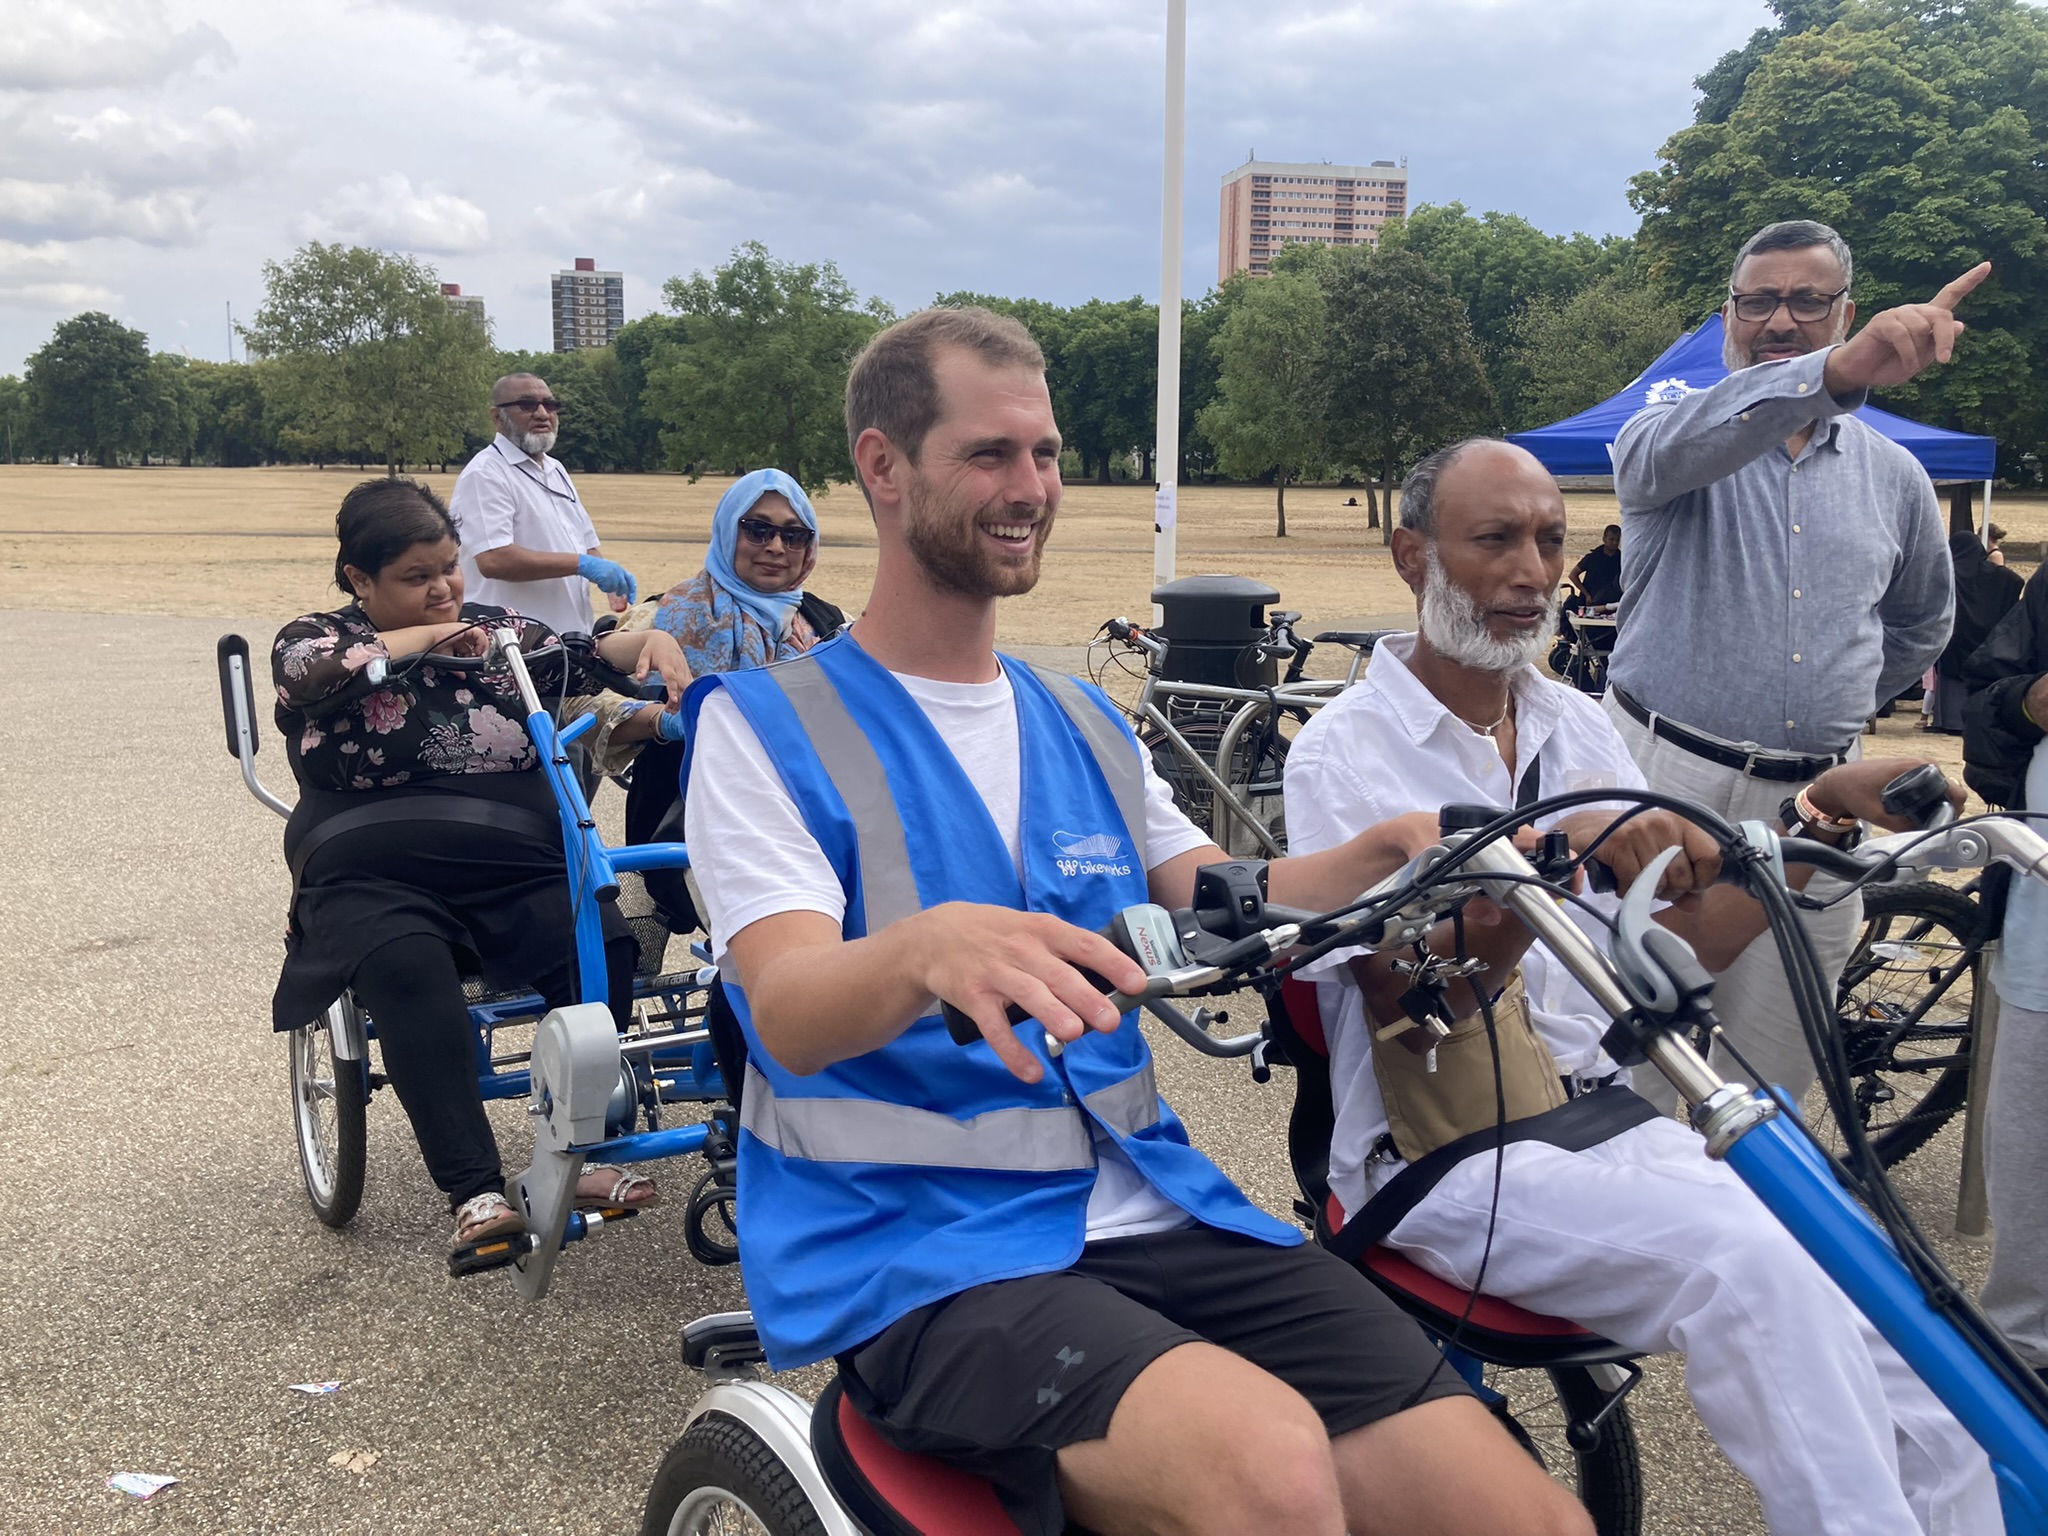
[739,1063,1096,1174]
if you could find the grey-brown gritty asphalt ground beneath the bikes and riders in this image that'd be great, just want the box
[0,610,1982,1536]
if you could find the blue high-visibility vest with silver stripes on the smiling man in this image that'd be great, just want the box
[684,637,1303,1370]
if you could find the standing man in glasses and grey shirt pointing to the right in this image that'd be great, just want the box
[1608,219,1991,1096]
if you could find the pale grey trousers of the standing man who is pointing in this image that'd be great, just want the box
[1608,692,1864,1114]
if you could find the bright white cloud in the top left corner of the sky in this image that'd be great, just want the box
[0,0,231,90]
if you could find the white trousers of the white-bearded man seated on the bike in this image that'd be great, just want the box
[1368,1120,2005,1536]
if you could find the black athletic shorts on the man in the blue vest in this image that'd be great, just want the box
[840,1227,1466,1536]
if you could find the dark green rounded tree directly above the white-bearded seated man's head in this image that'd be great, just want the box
[1319,248,1497,543]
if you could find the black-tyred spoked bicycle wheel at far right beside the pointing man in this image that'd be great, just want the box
[1806,881,1985,1167]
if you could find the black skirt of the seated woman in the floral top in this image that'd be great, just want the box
[270,772,631,1030]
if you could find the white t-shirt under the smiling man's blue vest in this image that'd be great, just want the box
[684,672,1208,1241]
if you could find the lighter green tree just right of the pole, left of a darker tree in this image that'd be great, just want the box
[1200,270,1327,539]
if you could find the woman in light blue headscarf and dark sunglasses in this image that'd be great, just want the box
[627,469,846,932]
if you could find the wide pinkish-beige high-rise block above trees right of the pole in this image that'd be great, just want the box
[1217,160,1409,283]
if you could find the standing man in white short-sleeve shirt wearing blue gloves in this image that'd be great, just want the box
[449,373,639,635]
